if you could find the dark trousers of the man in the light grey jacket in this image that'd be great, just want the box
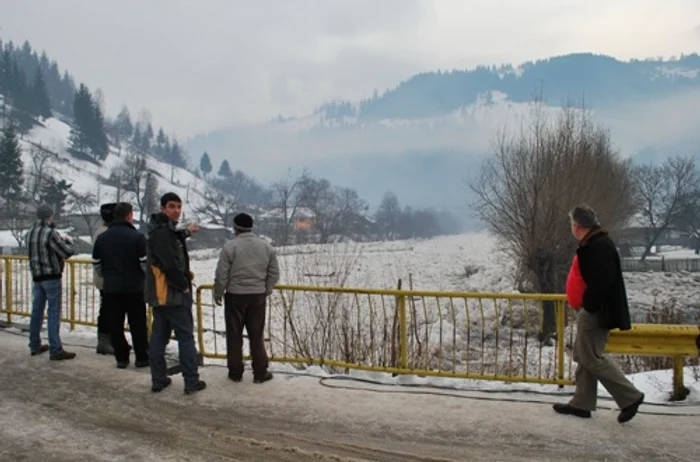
[224,294,268,377]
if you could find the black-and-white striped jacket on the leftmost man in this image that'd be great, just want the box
[27,220,75,282]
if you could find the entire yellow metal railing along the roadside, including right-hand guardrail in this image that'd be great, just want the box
[0,256,700,397]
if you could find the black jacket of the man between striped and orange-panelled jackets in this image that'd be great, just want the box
[92,220,146,294]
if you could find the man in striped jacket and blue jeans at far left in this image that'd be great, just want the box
[27,204,75,361]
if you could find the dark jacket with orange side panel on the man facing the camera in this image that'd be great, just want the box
[146,213,192,307]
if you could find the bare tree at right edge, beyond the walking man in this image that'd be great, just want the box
[633,157,700,261]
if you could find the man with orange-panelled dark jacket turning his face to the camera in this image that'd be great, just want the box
[146,193,207,395]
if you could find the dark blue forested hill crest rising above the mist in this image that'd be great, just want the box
[319,53,700,120]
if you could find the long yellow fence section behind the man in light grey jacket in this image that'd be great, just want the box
[196,285,574,385]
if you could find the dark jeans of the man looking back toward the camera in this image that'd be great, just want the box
[150,293,199,389]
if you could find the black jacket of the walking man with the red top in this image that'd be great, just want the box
[576,228,631,330]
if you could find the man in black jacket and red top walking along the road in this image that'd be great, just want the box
[554,205,644,423]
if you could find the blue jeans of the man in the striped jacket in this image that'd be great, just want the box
[29,279,63,355]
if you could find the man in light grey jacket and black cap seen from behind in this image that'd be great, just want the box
[214,213,279,383]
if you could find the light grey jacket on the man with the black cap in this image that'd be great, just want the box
[214,232,280,300]
